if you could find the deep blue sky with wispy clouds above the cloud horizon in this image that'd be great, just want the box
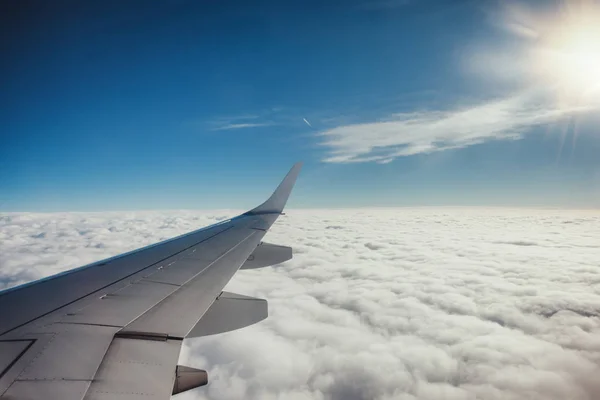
[0,0,600,211]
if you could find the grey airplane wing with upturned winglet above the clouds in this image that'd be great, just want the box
[0,164,301,400]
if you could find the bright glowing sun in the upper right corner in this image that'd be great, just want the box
[536,3,600,105]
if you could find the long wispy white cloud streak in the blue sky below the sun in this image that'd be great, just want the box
[318,93,590,163]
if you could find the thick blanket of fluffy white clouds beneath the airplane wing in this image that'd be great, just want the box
[0,208,600,400]
